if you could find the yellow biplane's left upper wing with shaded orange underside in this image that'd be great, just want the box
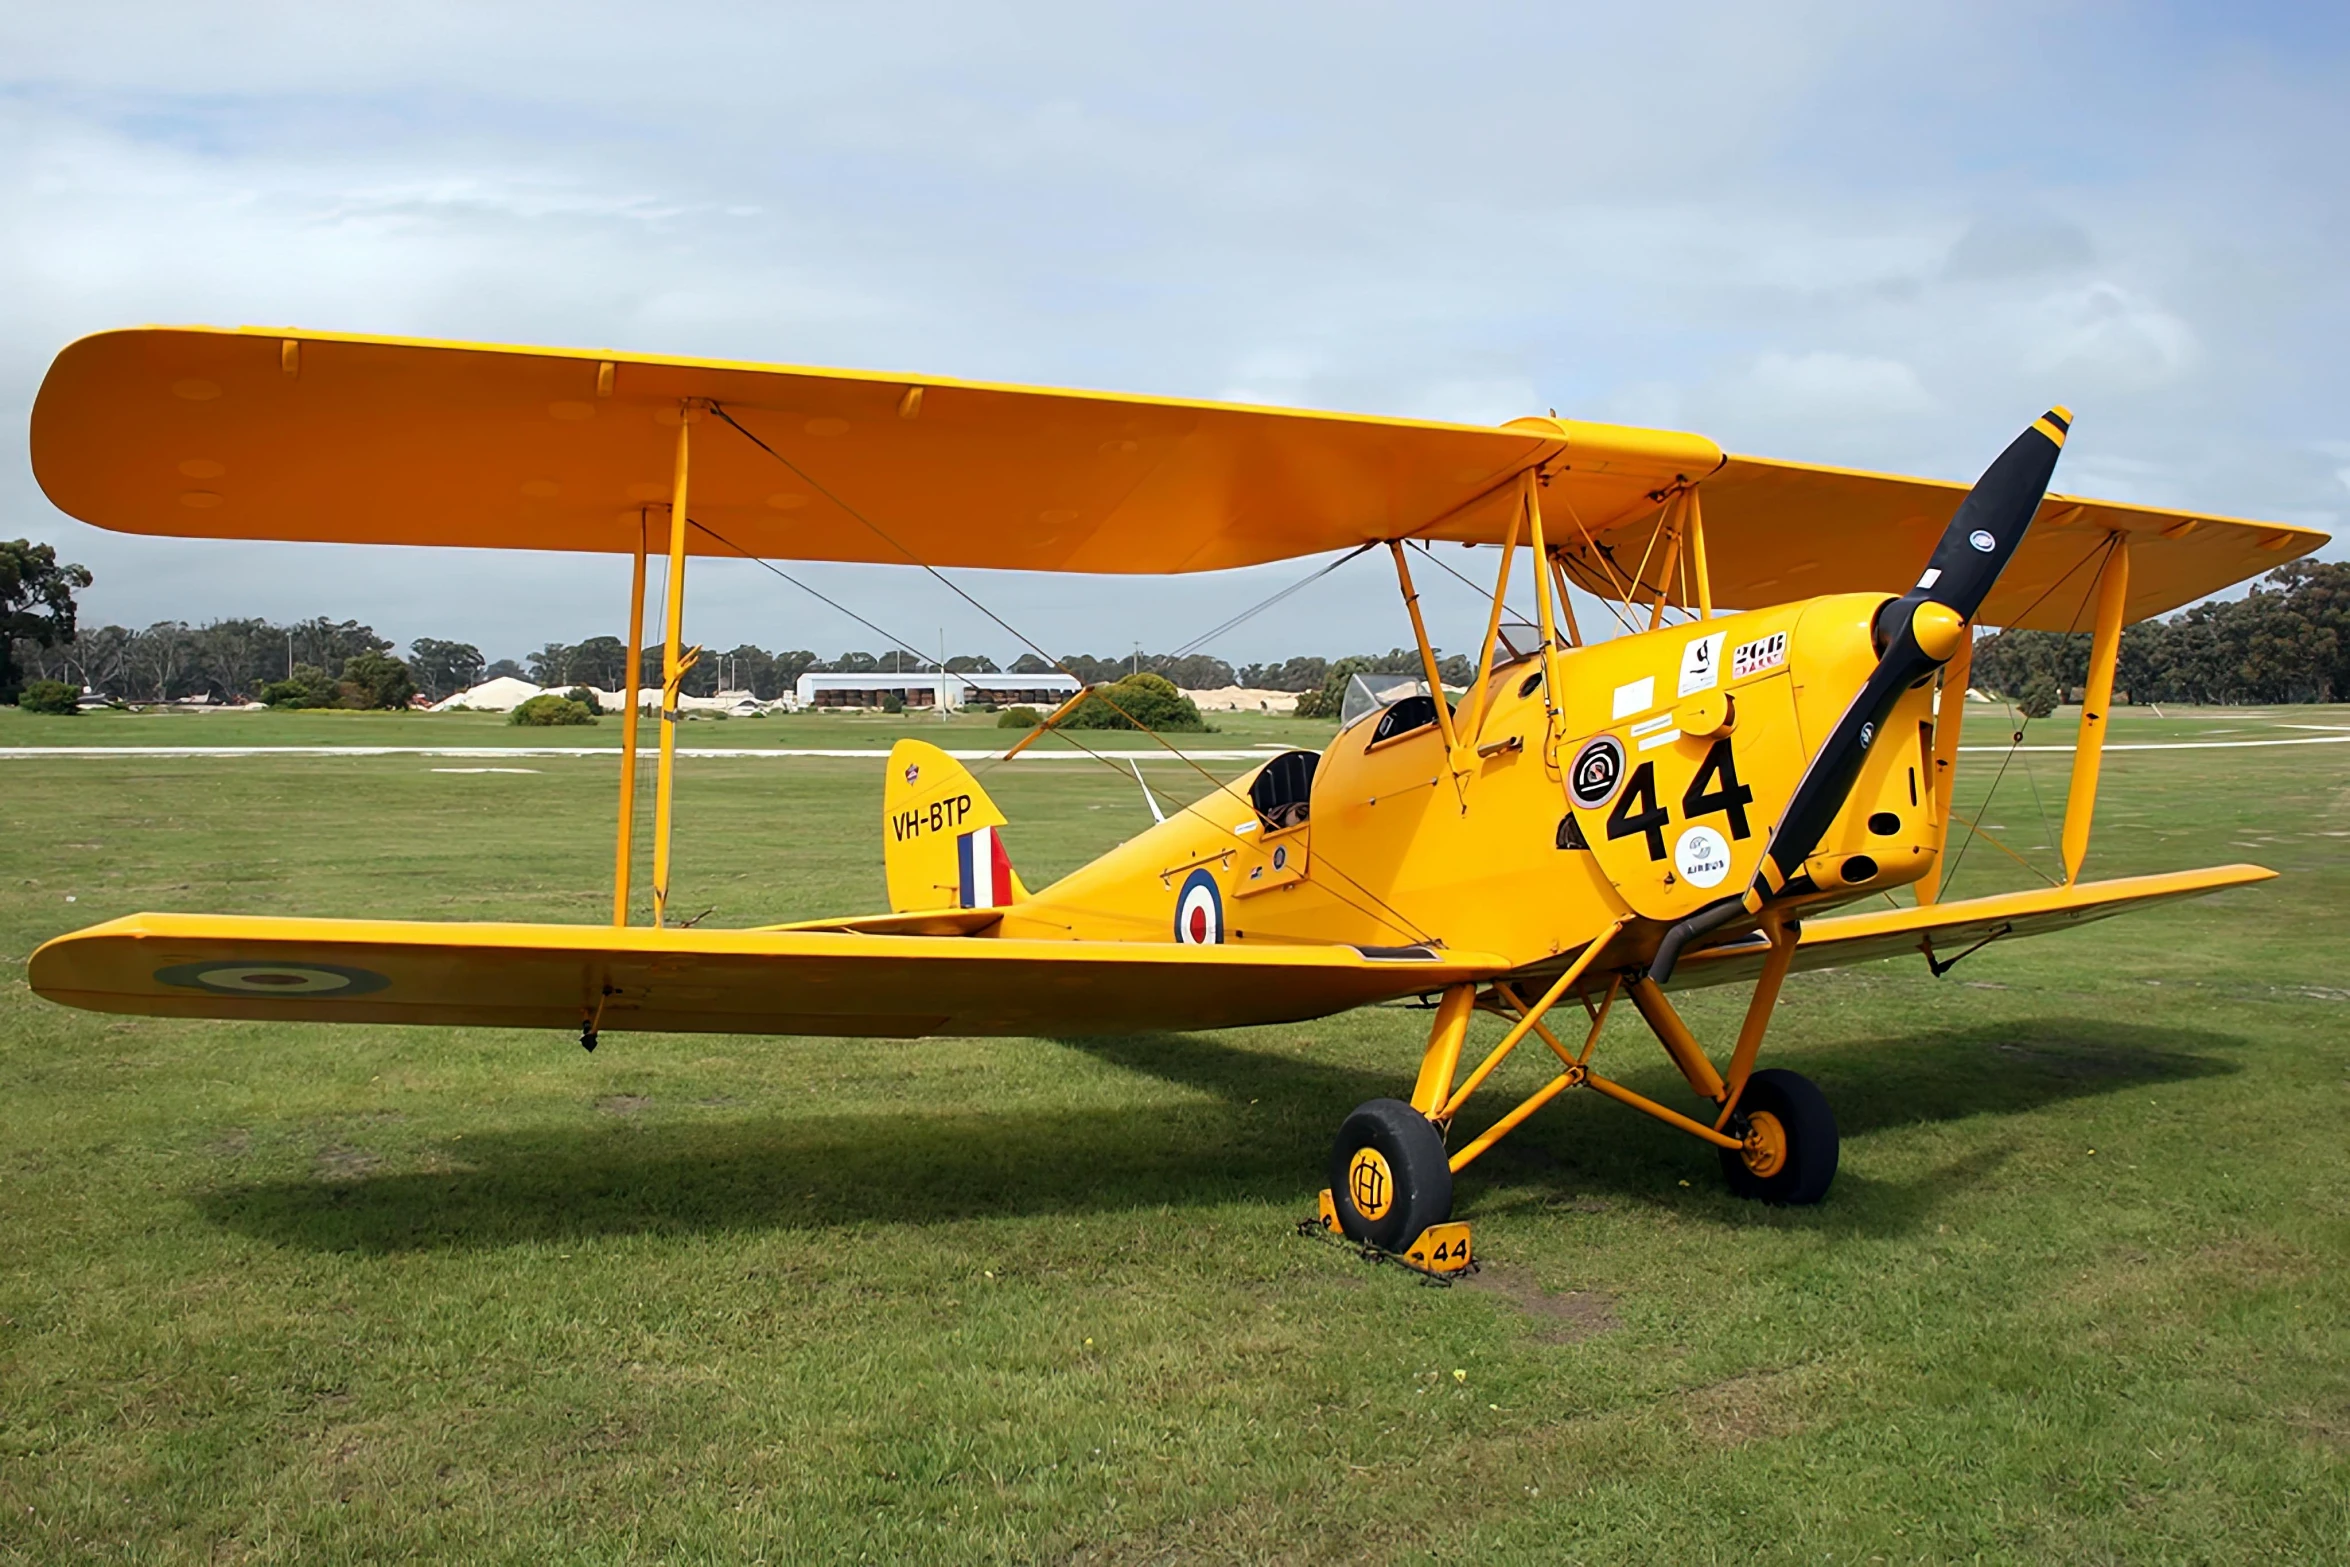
[33,327,1691,571]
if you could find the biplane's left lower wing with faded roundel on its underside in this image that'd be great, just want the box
[28,914,1504,1038]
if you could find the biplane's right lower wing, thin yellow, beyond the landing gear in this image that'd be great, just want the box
[1673,865,2277,989]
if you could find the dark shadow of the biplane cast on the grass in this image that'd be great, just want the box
[195,1020,2237,1252]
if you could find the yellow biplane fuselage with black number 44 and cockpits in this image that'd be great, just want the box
[1001,594,1955,968]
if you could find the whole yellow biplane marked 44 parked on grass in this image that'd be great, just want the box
[31,329,2324,1271]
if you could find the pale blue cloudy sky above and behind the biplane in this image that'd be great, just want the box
[0,0,2350,663]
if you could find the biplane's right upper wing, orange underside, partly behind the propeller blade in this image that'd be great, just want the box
[1551,456,2327,632]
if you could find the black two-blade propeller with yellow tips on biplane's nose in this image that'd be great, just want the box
[1647,409,2073,984]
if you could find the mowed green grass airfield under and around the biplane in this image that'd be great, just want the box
[0,709,2350,1562]
